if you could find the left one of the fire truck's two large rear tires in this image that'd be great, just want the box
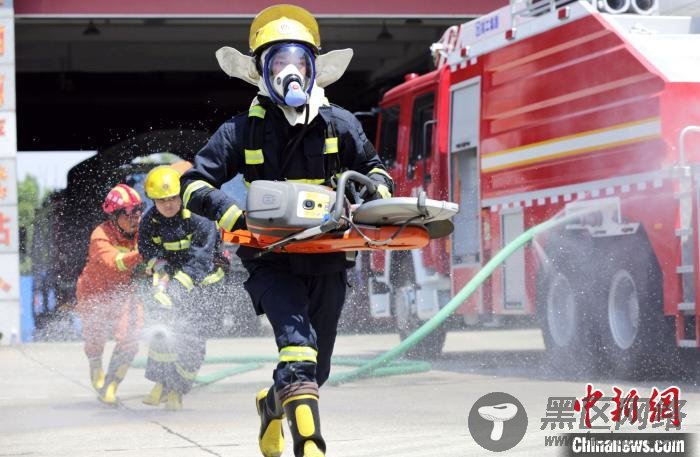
[537,261,600,375]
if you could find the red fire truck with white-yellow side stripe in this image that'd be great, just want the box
[369,0,700,374]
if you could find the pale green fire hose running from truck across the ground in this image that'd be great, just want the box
[132,209,591,385]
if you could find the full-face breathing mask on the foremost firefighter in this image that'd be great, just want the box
[262,43,316,108]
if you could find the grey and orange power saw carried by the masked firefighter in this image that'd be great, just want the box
[222,171,459,255]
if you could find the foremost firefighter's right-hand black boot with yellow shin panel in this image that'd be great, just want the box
[284,394,326,457]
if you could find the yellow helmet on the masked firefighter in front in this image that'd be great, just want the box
[248,4,321,54]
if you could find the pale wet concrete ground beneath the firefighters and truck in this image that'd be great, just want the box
[0,330,700,457]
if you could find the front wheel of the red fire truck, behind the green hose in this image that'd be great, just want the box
[393,285,447,358]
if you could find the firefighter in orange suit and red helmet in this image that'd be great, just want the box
[76,184,144,405]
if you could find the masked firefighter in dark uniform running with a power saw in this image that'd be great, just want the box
[182,5,393,457]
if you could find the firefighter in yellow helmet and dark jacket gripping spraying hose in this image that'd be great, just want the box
[139,165,224,410]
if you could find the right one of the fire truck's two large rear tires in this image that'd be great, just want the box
[599,243,678,379]
